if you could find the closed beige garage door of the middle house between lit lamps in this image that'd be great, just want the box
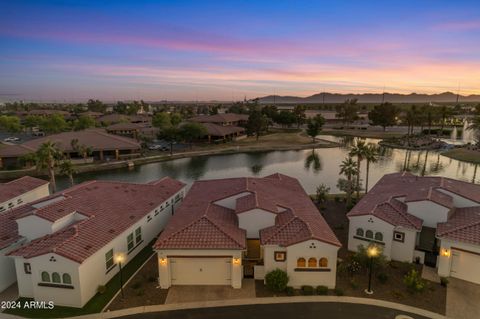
[170,257,232,285]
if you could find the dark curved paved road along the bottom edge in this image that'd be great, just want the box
[119,302,427,319]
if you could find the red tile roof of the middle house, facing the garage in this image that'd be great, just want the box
[154,174,341,250]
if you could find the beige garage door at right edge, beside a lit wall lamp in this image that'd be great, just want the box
[450,250,480,284]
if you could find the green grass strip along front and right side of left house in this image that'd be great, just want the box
[5,241,153,318]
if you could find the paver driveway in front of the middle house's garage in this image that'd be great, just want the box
[165,279,255,304]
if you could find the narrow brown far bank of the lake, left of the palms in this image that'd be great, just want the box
[0,138,340,181]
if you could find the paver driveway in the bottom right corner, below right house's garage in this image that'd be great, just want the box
[447,278,480,319]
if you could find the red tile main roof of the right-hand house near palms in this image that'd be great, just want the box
[347,172,480,229]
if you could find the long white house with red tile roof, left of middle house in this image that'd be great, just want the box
[8,178,185,307]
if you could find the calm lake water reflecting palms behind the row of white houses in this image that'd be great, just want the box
[58,136,480,193]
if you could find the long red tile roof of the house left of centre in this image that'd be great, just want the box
[9,177,185,263]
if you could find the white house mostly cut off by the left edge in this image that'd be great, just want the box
[0,176,49,292]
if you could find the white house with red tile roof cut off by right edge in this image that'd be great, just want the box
[347,172,480,284]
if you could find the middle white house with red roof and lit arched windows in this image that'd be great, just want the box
[154,174,341,288]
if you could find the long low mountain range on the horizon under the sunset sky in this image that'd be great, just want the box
[259,92,480,104]
